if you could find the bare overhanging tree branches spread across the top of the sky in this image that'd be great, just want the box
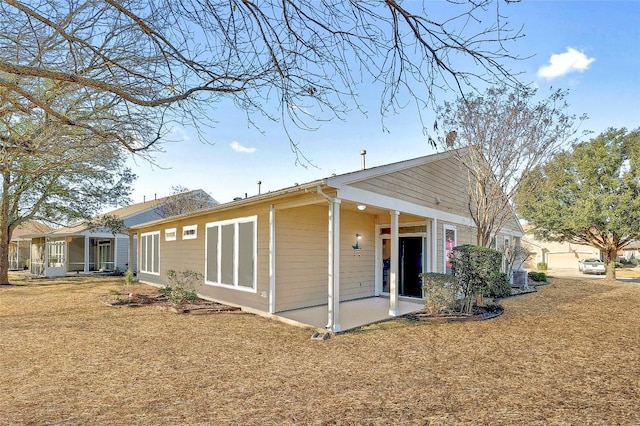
[0,0,522,158]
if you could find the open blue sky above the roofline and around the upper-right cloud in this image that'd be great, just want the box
[130,0,640,206]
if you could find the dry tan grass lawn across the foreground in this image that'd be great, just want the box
[0,272,640,425]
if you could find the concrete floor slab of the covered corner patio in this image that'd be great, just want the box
[275,296,424,331]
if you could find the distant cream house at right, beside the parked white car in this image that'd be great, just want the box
[522,225,600,270]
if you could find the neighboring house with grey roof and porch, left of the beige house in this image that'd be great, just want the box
[29,190,218,277]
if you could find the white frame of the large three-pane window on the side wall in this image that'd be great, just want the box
[204,216,258,293]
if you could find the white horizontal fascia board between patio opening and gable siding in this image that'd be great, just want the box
[337,186,475,226]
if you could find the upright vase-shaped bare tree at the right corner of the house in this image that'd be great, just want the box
[438,85,586,247]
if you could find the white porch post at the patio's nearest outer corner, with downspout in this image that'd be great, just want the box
[327,198,342,333]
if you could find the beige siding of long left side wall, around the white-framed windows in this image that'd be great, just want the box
[138,204,269,311]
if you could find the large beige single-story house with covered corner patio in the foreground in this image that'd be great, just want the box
[130,152,523,332]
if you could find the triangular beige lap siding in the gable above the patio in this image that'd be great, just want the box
[351,158,466,215]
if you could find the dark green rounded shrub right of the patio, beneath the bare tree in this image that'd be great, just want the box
[451,244,504,313]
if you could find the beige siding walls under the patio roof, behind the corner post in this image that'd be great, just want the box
[276,203,375,312]
